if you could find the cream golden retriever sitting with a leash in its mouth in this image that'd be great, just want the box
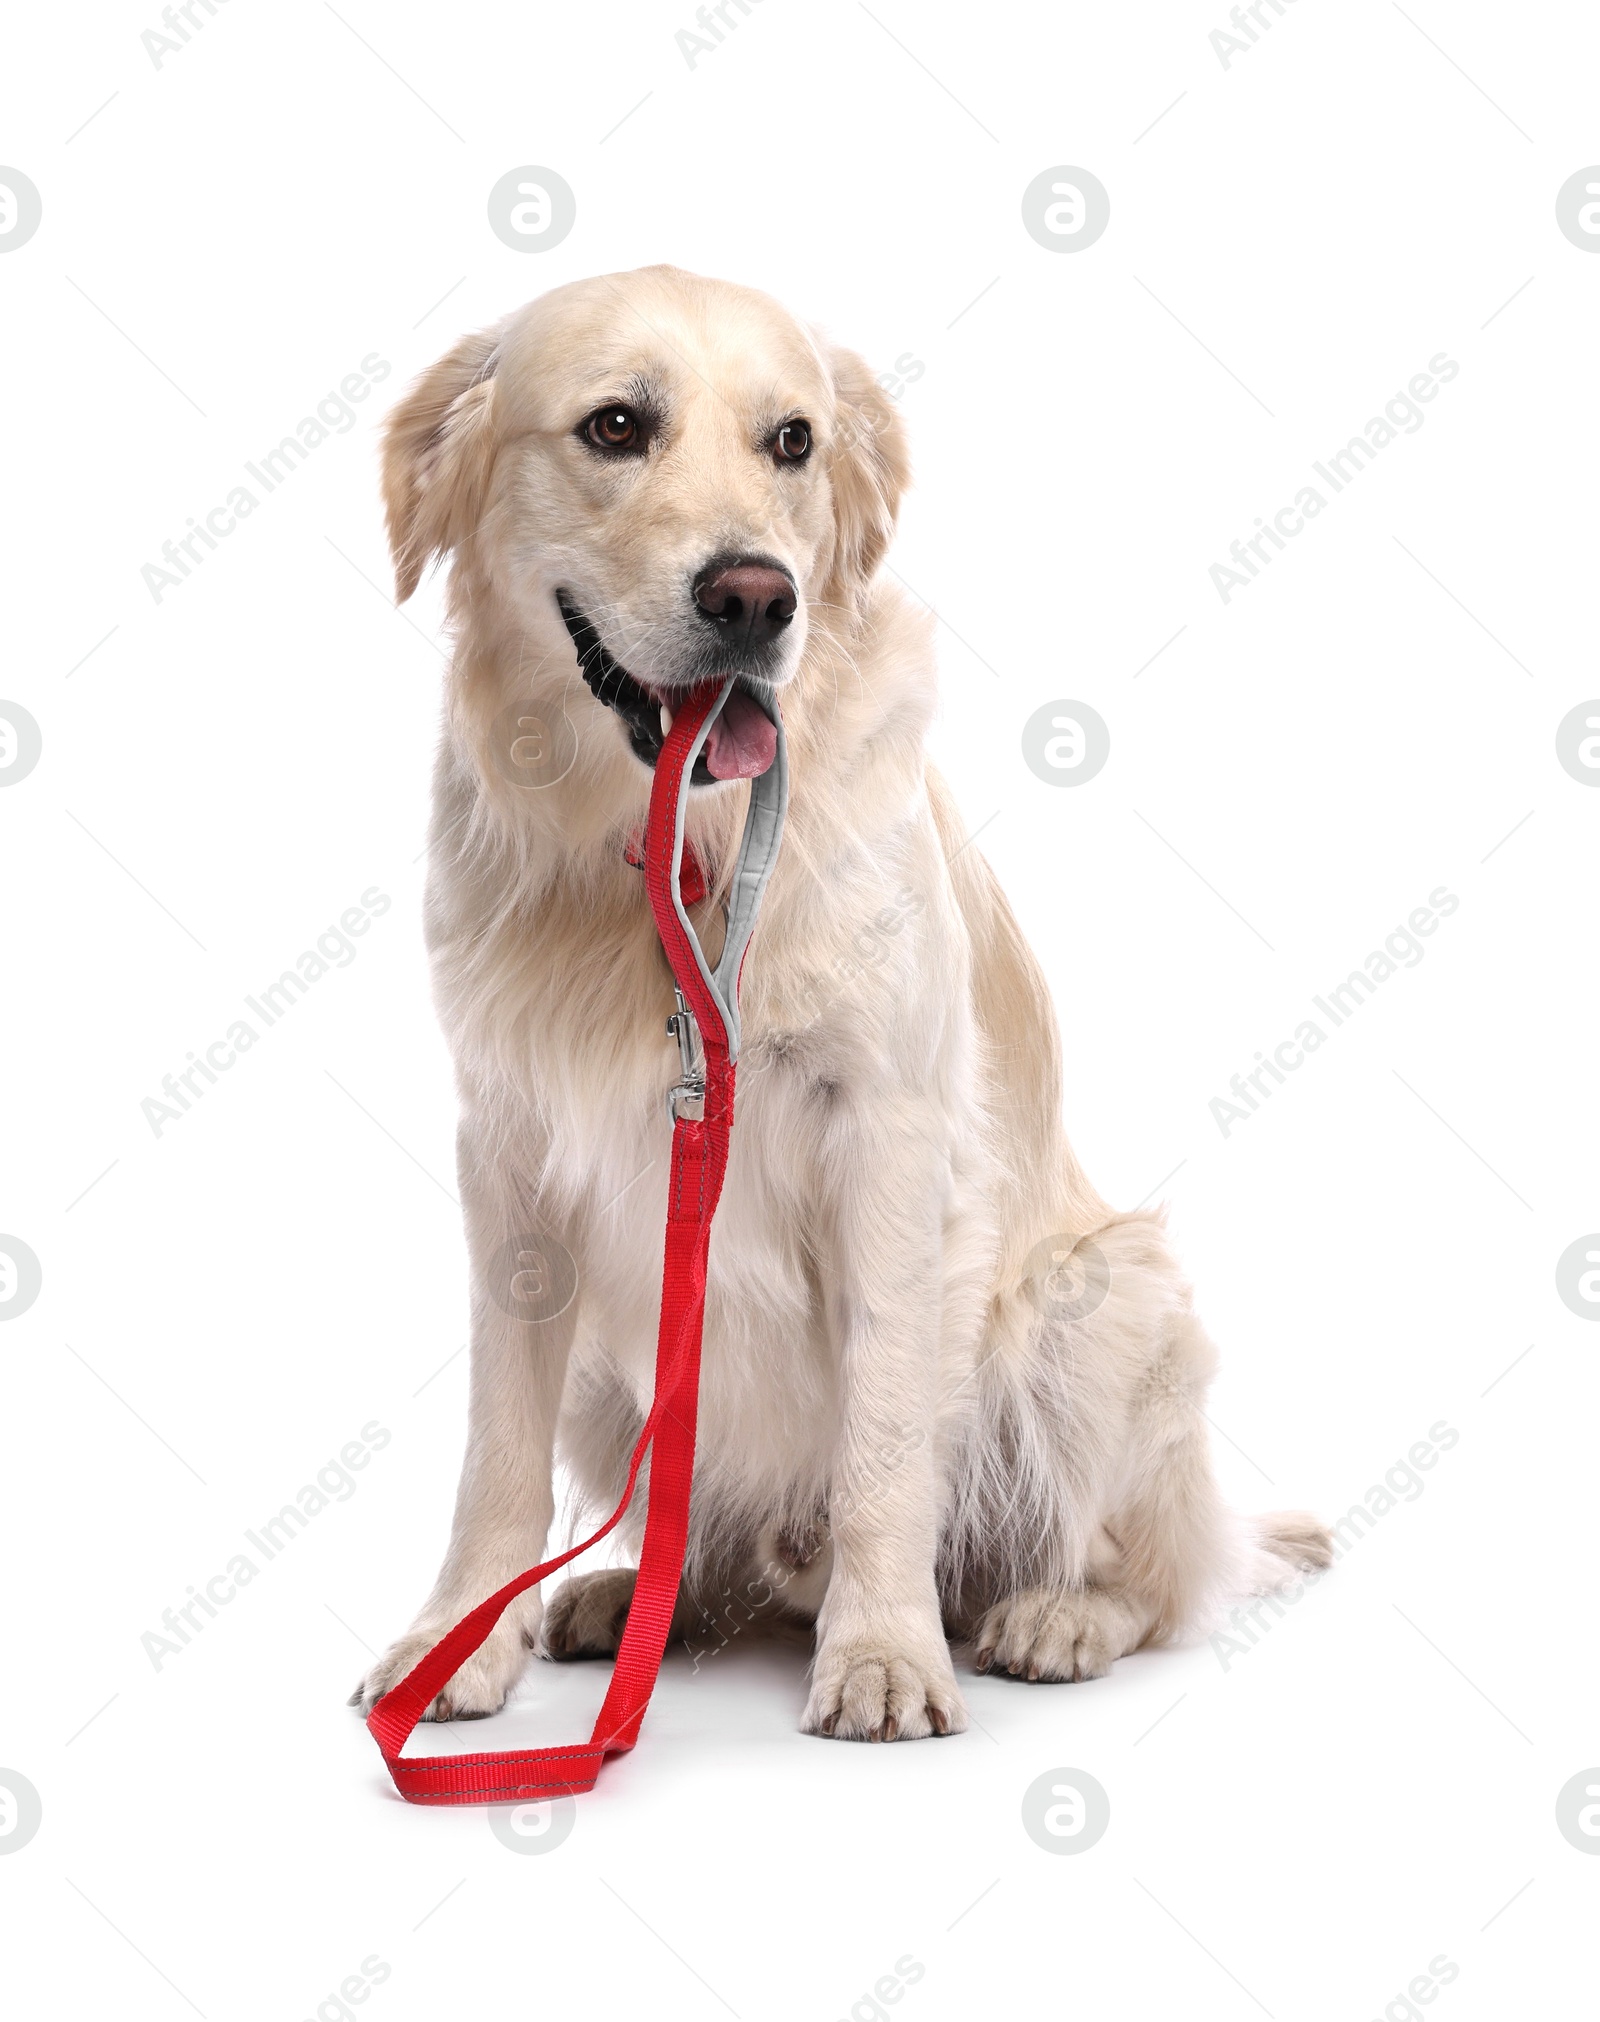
[356,267,1329,1741]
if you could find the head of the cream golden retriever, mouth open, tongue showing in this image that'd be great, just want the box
[384,267,906,778]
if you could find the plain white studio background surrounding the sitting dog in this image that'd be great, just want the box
[0,0,1600,2022]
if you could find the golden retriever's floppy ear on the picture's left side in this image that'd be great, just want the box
[384,330,500,605]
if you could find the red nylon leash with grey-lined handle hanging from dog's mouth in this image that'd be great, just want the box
[366,675,789,1804]
